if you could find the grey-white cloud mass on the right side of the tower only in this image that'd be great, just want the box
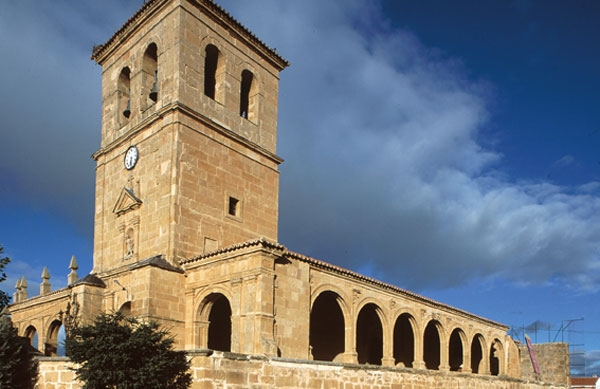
[219,1,600,290]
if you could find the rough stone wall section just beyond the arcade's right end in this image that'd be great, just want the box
[519,343,569,385]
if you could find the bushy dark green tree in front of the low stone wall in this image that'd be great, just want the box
[65,312,191,389]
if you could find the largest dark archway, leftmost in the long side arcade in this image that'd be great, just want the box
[309,291,345,361]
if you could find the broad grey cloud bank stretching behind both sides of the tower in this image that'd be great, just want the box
[0,0,600,289]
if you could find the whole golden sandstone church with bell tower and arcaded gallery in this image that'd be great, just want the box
[9,0,569,388]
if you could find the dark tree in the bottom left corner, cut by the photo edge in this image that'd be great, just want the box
[0,313,38,389]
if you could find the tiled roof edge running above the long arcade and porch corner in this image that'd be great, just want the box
[181,238,509,330]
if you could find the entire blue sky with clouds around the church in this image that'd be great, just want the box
[0,0,600,374]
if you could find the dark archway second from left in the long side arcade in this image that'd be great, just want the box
[356,303,383,365]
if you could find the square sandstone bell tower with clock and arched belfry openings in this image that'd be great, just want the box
[92,0,288,278]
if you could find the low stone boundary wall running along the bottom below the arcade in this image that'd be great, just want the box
[36,350,568,389]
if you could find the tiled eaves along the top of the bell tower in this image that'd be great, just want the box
[91,0,290,70]
